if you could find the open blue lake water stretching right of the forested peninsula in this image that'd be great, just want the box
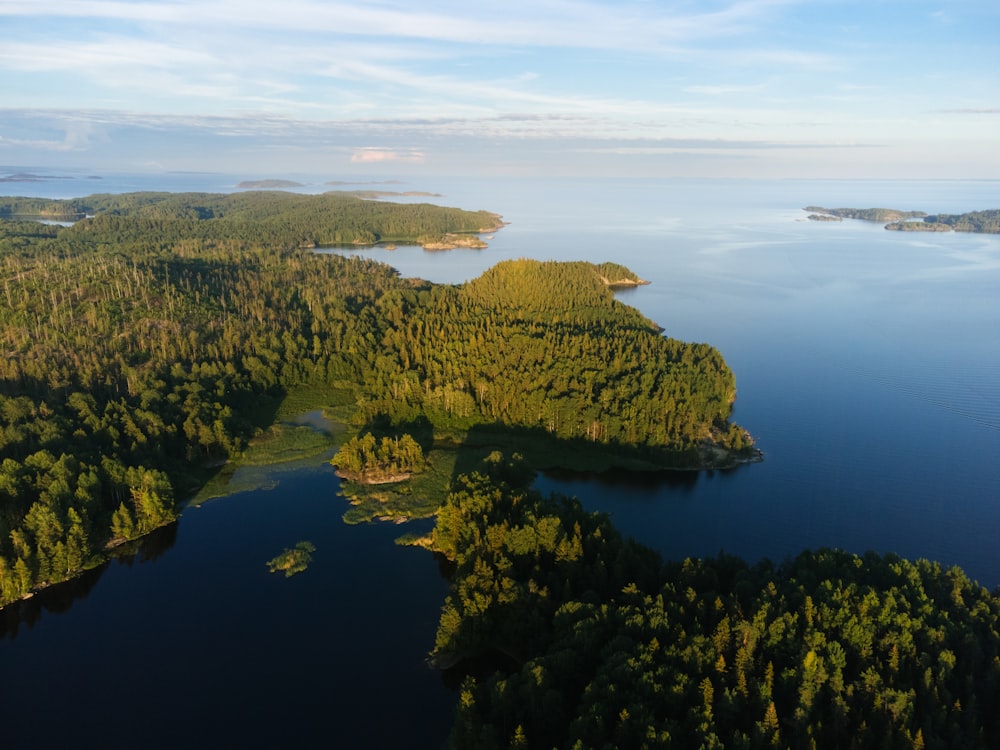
[332,181,1000,588]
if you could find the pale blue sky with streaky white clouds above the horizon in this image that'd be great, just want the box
[0,0,1000,179]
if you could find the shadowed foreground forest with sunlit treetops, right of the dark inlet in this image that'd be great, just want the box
[428,455,1000,750]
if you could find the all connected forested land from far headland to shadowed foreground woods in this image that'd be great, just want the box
[0,192,1000,748]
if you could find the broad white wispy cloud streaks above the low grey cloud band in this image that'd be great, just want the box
[0,0,835,116]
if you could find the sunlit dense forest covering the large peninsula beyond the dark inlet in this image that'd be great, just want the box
[0,193,753,603]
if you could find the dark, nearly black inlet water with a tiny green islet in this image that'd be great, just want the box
[0,467,453,748]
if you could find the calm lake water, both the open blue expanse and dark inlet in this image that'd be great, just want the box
[0,170,1000,748]
